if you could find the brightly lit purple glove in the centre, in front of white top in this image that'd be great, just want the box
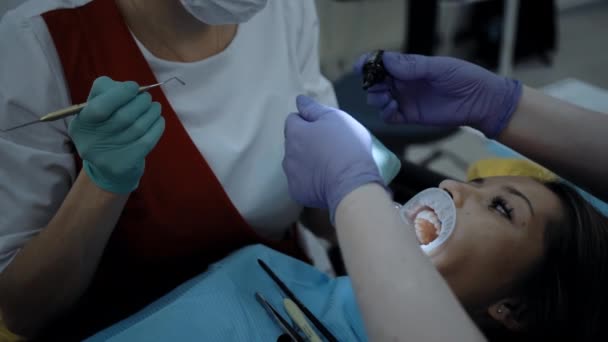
[283,96,384,221]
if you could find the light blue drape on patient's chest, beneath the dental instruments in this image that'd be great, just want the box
[86,245,367,342]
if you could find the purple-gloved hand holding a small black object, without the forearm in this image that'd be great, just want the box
[355,52,522,138]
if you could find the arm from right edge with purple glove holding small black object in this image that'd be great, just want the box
[358,52,608,200]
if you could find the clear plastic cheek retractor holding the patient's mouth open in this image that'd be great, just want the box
[399,188,456,254]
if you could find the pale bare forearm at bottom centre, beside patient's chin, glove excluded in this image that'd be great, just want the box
[336,184,484,342]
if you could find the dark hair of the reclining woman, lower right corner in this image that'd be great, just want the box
[481,182,608,341]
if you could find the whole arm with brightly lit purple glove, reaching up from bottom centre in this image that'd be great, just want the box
[283,97,483,341]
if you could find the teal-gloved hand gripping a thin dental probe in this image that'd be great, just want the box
[68,77,165,194]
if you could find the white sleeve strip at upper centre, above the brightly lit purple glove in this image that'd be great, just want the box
[296,0,338,107]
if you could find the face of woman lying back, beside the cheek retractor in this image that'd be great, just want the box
[431,177,561,309]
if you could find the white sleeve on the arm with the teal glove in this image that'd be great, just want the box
[0,11,75,272]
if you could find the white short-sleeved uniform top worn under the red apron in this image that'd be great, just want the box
[0,0,336,271]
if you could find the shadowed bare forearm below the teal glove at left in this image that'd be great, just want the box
[0,171,128,338]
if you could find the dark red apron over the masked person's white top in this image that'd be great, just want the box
[43,0,303,341]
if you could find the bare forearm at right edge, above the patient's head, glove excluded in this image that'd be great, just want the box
[499,87,608,200]
